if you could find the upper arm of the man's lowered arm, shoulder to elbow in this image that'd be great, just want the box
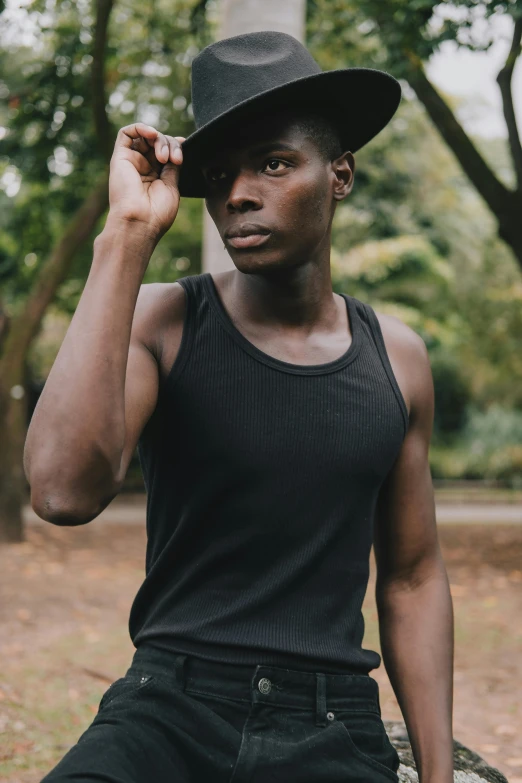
[374,336,439,584]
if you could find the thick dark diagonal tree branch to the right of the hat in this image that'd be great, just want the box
[405,51,513,217]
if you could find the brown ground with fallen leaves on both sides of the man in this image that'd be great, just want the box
[0,520,522,783]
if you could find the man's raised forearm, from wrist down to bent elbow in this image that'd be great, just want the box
[24,215,154,518]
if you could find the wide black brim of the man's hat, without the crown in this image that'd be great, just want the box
[178,68,401,198]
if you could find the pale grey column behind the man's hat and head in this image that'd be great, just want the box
[202,0,305,272]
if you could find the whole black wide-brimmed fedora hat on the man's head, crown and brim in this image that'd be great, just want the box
[178,30,401,198]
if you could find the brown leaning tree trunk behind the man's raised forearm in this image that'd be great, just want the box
[0,173,109,542]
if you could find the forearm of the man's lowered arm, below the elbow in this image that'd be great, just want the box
[376,558,454,783]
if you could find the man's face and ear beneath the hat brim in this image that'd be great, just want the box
[203,113,354,273]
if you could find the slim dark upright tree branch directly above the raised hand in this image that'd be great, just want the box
[91,0,116,161]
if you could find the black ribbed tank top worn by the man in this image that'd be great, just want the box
[129,273,408,673]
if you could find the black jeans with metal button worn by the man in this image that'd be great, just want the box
[42,646,400,783]
